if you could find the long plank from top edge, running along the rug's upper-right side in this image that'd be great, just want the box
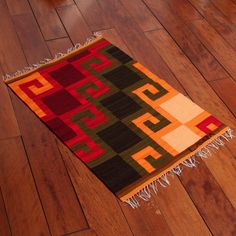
[97,0,185,93]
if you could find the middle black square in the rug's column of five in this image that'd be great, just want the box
[101,92,141,119]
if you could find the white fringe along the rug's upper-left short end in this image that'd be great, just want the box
[2,32,101,82]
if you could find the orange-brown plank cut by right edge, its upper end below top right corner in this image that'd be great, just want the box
[191,20,236,80]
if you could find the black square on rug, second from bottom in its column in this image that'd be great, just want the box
[97,121,142,153]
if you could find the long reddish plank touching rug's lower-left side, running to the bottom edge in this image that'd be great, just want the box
[11,91,87,235]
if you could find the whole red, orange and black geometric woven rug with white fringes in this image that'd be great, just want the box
[4,35,233,208]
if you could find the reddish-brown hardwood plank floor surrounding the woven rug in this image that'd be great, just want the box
[0,0,236,236]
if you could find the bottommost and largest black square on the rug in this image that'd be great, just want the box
[92,156,141,193]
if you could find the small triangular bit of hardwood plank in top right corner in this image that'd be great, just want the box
[212,0,236,24]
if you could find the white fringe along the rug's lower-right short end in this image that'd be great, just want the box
[125,128,235,209]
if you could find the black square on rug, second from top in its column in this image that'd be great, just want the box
[103,65,142,89]
